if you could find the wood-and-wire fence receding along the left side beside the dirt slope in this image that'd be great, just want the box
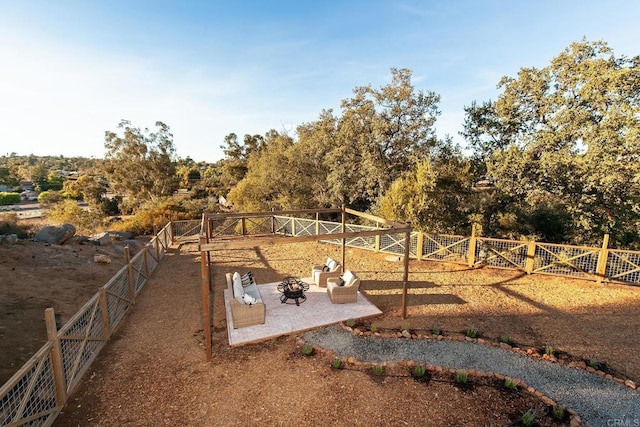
[0,223,172,426]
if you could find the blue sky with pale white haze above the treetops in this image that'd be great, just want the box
[0,0,640,162]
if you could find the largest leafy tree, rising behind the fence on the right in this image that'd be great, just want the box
[463,40,640,244]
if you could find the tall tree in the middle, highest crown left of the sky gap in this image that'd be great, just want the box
[327,68,440,209]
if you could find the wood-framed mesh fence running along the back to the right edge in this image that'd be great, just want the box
[274,216,640,285]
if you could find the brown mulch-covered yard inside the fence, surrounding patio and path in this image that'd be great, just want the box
[0,239,640,426]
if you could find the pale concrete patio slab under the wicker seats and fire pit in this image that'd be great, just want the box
[224,277,382,347]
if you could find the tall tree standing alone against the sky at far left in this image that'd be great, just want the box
[104,120,178,211]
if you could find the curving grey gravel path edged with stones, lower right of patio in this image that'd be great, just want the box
[303,326,640,426]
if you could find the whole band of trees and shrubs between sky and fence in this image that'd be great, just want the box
[0,40,640,248]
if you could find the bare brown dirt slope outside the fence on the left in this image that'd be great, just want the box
[0,240,131,384]
